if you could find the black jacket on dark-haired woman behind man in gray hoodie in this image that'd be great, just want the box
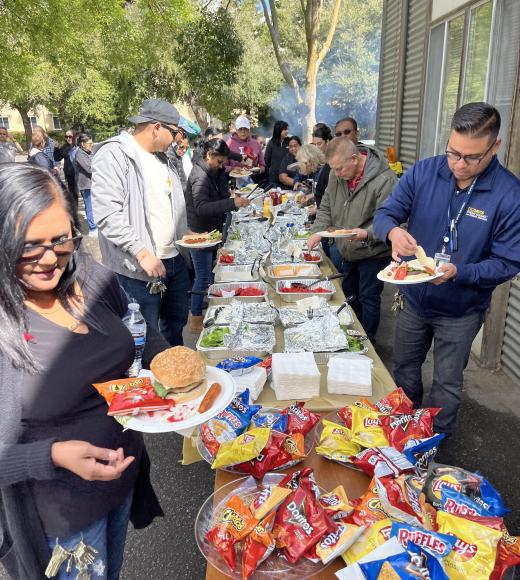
[185,160,235,234]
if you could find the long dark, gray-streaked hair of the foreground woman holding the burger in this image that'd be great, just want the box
[0,163,77,374]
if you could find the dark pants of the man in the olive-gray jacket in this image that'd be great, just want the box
[340,256,388,342]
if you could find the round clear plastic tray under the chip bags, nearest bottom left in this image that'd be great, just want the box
[195,473,333,580]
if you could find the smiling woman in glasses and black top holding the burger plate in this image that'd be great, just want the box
[0,164,165,580]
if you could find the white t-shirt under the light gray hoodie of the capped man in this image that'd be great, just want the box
[136,141,179,259]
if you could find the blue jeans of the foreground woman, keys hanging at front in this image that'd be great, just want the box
[47,493,133,580]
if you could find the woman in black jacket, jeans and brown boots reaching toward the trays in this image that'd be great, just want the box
[185,139,250,332]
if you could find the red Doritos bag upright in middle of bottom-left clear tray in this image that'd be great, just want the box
[274,478,335,564]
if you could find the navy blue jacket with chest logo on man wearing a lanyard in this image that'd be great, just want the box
[374,156,520,317]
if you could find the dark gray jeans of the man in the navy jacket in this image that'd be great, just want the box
[393,305,485,433]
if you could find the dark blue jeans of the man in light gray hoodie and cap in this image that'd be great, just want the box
[117,254,191,346]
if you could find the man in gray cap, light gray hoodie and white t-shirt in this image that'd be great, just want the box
[92,99,190,346]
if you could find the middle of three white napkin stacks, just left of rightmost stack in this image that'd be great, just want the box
[272,352,320,401]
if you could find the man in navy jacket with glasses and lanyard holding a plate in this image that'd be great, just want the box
[374,103,520,434]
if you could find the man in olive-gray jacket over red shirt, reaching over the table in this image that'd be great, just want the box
[308,137,397,342]
